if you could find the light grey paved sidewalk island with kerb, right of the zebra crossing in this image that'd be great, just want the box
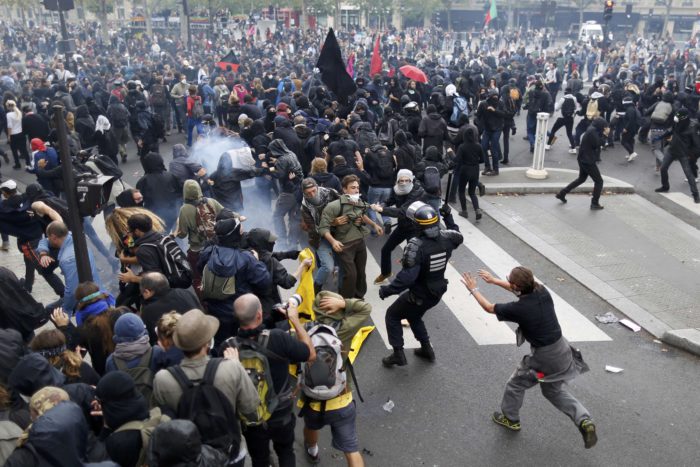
[470,168,700,355]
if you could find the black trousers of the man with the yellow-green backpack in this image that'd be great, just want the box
[243,413,296,467]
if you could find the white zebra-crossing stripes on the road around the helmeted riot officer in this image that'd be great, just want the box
[365,214,612,348]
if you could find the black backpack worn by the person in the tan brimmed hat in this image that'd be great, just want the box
[168,358,241,457]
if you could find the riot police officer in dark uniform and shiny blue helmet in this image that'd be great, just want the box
[379,201,463,367]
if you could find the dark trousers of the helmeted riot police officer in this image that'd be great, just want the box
[384,290,440,349]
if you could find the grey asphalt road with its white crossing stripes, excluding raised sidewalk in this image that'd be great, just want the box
[3,113,700,467]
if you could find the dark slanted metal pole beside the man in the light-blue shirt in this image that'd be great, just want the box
[53,105,93,282]
